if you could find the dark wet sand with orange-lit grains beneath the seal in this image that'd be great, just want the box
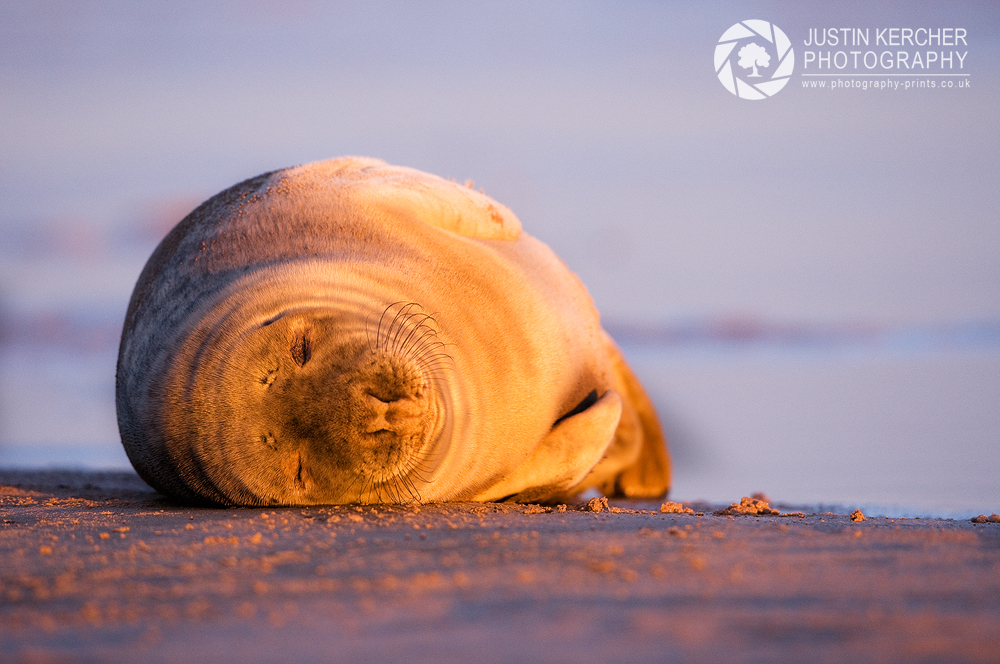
[0,471,1000,664]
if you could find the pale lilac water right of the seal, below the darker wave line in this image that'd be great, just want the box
[626,346,1000,515]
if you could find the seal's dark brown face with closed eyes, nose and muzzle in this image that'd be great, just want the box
[260,320,430,502]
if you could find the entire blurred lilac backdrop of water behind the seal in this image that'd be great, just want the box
[0,0,1000,513]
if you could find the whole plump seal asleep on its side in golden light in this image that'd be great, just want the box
[116,158,670,505]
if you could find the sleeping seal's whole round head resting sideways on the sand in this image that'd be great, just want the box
[146,293,450,505]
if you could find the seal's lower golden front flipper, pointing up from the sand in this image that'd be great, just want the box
[477,390,622,503]
